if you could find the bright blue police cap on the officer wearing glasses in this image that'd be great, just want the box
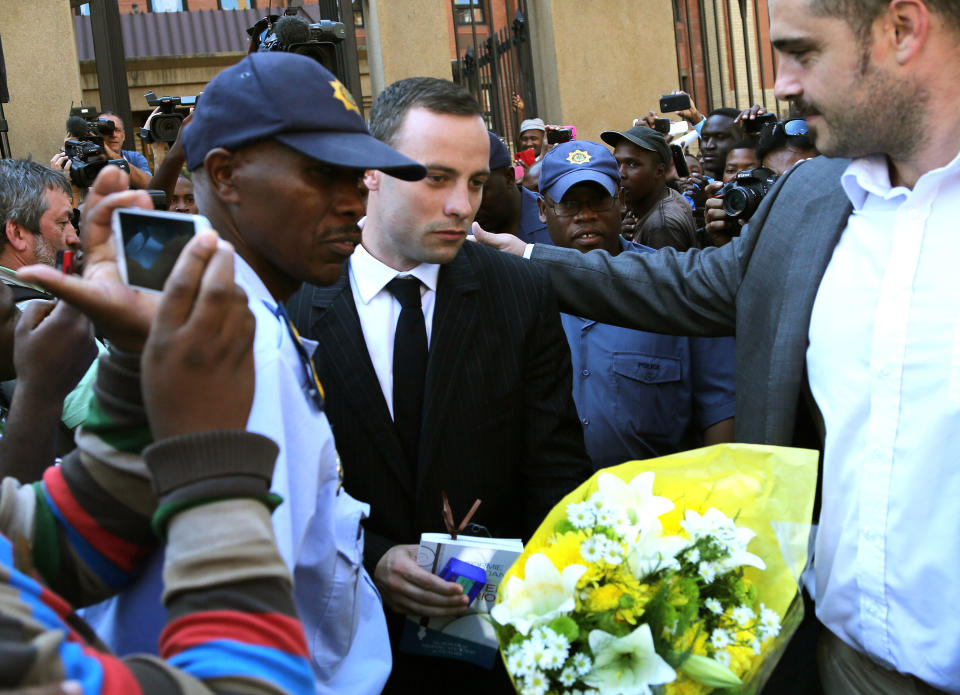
[540,140,620,200]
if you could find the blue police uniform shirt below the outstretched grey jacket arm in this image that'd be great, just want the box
[562,239,735,469]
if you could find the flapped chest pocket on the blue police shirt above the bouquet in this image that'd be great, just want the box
[613,352,690,437]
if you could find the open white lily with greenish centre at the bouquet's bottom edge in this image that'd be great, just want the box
[583,623,677,695]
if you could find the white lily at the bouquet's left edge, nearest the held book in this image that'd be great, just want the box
[490,553,587,635]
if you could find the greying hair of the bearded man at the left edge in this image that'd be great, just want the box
[0,159,73,248]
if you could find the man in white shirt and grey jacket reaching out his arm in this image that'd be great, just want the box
[479,0,960,695]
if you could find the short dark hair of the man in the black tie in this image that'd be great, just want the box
[370,77,483,143]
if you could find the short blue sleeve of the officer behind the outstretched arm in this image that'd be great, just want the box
[690,337,736,432]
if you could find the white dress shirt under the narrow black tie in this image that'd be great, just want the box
[350,244,440,417]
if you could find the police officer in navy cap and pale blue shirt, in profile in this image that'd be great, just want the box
[71,53,426,695]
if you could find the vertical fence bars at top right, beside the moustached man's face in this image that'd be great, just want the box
[673,0,787,117]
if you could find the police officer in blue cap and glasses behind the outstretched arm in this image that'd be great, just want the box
[539,140,734,468]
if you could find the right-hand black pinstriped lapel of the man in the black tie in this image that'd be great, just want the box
[416,250,480,494]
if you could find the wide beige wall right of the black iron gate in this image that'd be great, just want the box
[527,0,678,141]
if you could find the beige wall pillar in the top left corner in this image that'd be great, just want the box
[0,0,80,162]
